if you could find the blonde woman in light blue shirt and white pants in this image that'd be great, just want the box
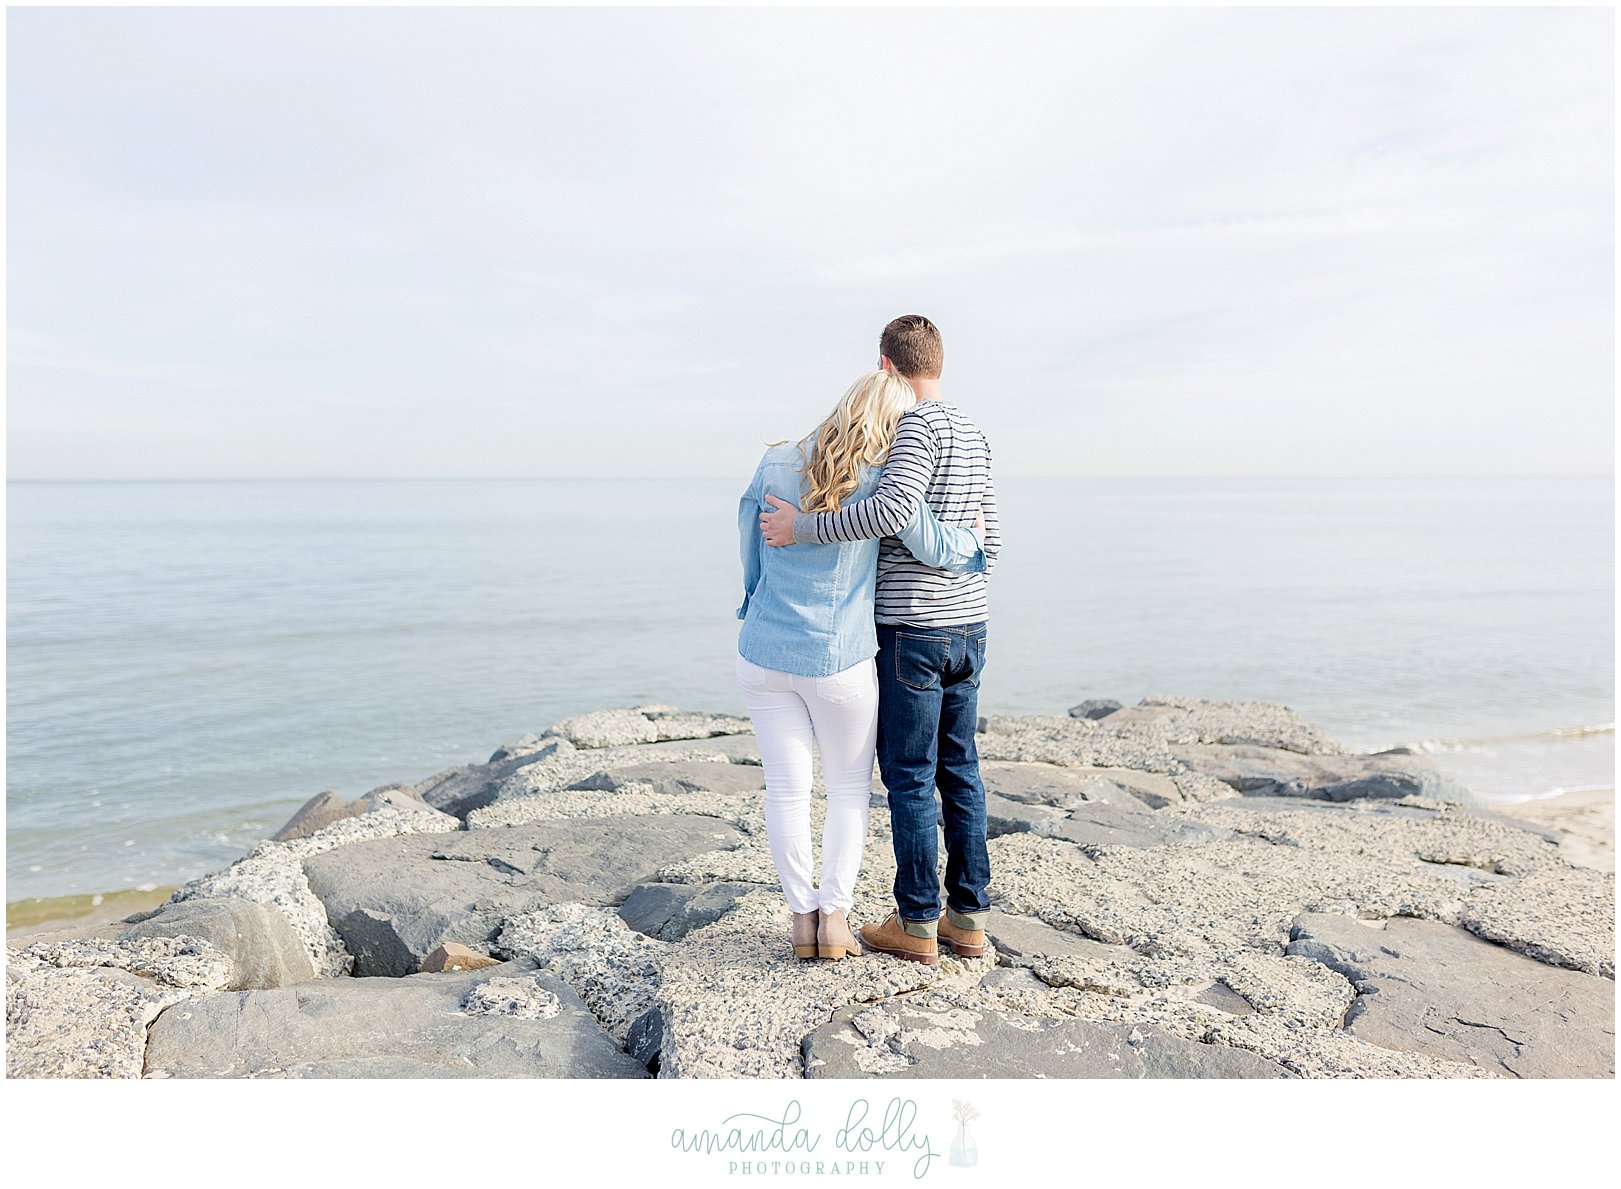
[738,371,986,959]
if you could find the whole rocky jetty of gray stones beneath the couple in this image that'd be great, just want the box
[6,698,1615,1077]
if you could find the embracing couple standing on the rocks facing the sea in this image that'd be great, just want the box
[738,315,1002,964]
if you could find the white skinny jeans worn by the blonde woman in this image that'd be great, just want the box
[738,655,879,912]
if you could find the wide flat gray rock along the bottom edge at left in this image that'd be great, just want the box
[146,962,647,1077]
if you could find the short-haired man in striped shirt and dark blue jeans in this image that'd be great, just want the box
[760,315,1002,965]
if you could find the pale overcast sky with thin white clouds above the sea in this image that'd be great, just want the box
[6,8,1615,477]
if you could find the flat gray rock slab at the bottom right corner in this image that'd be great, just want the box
[1289,913,1615,1077]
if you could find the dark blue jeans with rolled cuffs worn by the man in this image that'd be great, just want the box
[877,623,990,934]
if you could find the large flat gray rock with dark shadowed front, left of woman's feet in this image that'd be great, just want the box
[305,814,741,977]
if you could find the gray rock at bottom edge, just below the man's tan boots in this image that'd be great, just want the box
[804,994,1292,1079]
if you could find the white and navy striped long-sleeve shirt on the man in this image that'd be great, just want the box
[794,401,1002,628]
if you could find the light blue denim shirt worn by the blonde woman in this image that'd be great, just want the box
[738,443,986,676]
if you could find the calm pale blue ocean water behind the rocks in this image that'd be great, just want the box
[6,477,1615,900]
